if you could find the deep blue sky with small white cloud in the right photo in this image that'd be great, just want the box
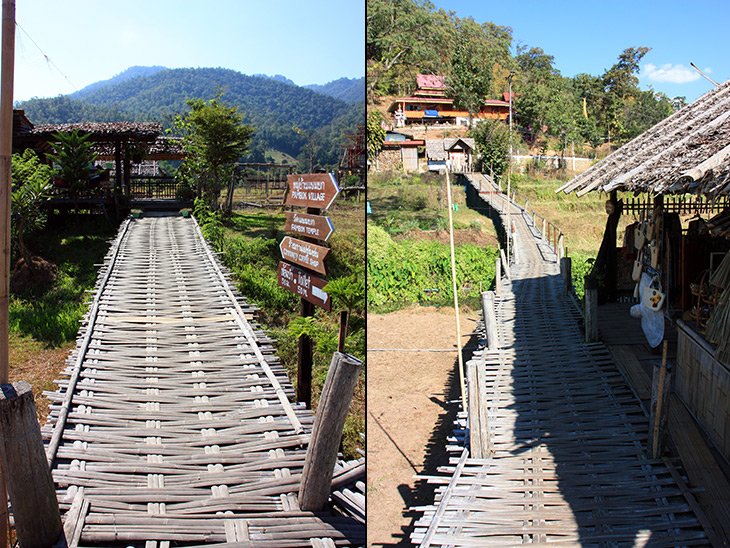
[433,0,730,102]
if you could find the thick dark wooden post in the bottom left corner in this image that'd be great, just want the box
[0,381,61,548]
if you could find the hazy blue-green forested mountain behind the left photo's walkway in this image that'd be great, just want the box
[17,67,365,169]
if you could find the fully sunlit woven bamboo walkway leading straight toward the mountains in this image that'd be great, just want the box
[44,216,364,548]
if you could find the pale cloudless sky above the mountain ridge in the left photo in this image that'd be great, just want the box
[14,0,365,101]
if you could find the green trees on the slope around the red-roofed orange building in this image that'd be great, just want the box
[366,0,685,147]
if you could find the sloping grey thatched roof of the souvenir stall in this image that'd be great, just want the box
[556,80,730,197]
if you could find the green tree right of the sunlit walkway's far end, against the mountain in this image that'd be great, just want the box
[181,91,254,214]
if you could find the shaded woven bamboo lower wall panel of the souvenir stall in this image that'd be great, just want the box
[674,325,730,461]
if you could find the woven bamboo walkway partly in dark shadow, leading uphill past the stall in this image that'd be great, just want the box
[411,178,710,547]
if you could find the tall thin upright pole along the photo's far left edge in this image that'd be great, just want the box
[0,0,15,546]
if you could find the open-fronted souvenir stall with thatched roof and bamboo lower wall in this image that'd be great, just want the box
[556,81,730,460]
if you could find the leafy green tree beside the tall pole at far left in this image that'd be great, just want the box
[11,149,53,271]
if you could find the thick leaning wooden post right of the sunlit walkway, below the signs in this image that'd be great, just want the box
[299,352,362,512]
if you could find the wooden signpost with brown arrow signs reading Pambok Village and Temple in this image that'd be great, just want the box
[278,173,340,408]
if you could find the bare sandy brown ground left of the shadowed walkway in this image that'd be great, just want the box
[367,307,477,547]
